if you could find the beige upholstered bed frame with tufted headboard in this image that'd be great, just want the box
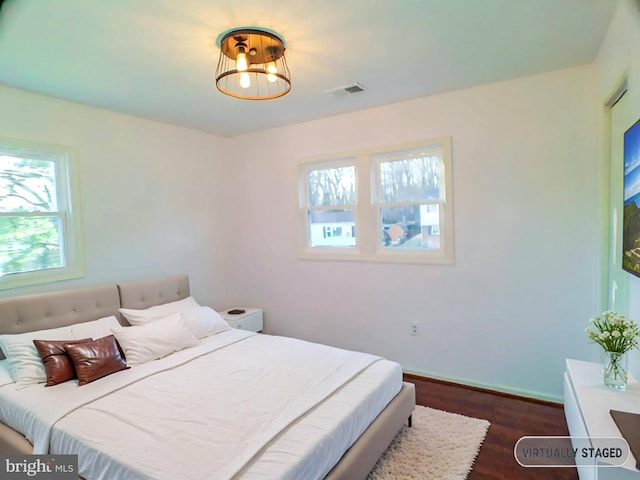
[0,275,415,480]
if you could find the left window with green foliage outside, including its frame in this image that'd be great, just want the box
[0,141,83,289]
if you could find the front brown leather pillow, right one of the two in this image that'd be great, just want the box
[64,335,129,385]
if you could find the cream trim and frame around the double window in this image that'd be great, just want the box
[297,137,455,265]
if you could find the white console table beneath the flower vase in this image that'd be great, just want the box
[564,360,640,480]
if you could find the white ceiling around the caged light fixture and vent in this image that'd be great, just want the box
[0,0,618,137]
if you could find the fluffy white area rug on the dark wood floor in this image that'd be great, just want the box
[369,405,489,480]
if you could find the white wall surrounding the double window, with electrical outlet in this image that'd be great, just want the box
[232,66,601,400]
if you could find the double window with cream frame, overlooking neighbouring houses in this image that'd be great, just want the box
[299,138,453,263]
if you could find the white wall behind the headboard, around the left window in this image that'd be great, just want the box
[0,86,235,304]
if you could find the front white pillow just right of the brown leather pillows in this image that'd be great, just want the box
[111,312,199,367]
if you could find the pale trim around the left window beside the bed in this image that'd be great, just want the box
[0,138,85,290]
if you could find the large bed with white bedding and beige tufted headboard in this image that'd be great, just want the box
[0,275,415,480]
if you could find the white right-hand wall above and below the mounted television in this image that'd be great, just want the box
[595,0,640,379]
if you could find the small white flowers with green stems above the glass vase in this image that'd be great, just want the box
[585,310,640,353]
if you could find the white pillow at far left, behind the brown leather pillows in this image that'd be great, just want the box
[0,327,74,388]
